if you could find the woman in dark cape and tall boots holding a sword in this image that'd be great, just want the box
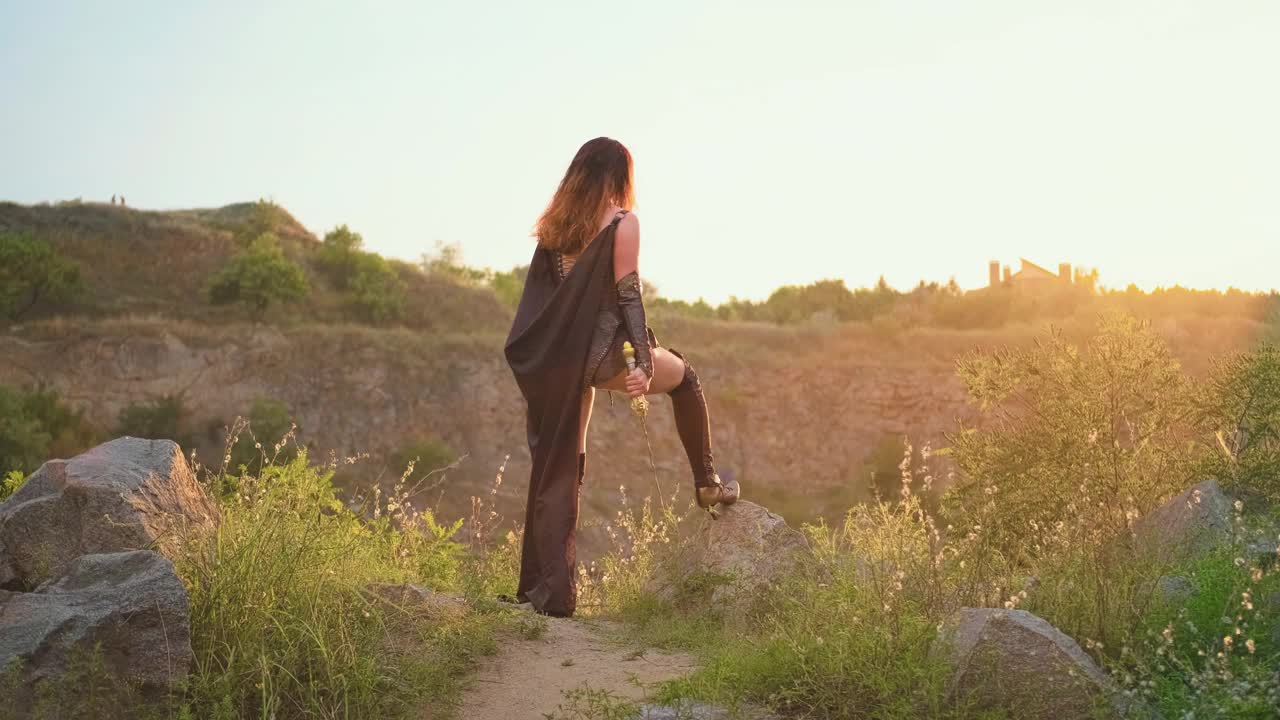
[506,137,739,616]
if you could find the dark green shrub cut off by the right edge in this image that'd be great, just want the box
[1202,343,1280,502]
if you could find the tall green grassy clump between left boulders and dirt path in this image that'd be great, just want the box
[177,451,493,720]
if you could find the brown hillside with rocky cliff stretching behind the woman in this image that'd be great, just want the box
[0,198,1267,555]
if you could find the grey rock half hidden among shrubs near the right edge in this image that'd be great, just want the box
[1133,480,1234,561]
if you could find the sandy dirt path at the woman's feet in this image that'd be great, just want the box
[458,609,696,720]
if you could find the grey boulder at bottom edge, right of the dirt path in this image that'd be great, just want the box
[941,607,1125,720]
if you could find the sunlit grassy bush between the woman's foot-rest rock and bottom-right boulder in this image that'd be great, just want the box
[637,447,980,719]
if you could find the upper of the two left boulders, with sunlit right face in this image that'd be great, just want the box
[0,437,218,589]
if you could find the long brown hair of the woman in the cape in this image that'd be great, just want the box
[534,137,635,255]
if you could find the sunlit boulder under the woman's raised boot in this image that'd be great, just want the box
[648,500,809,609]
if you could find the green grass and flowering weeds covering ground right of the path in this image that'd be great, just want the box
[581,430,1280,720]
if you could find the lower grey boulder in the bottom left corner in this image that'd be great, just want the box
[0,551,192,716]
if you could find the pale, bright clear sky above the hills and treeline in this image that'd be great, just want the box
[0,0,1280,302]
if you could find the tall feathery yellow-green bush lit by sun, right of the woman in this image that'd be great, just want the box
[948,313,1194,556]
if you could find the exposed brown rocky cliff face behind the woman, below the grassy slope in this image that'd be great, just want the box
[0,319,973,552]
